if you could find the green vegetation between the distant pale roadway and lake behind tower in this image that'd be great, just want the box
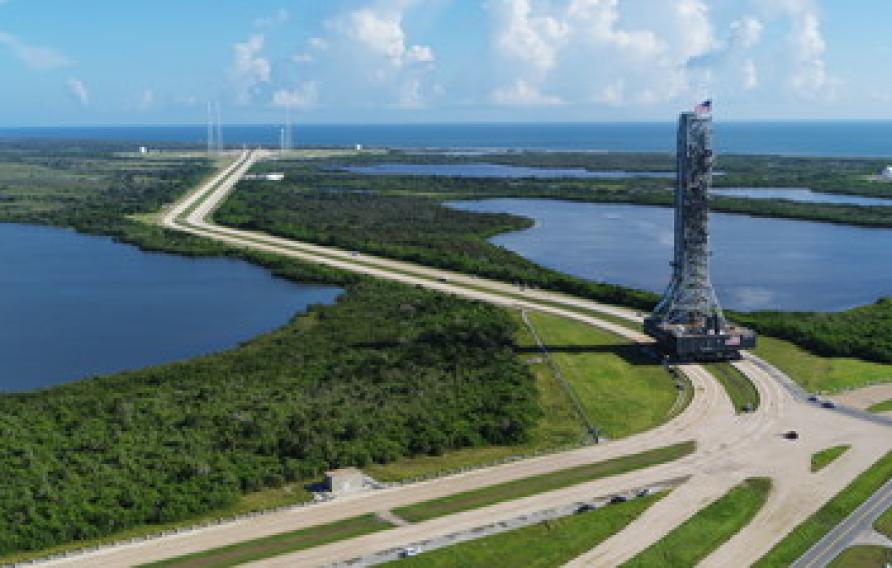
[215,171,657,308]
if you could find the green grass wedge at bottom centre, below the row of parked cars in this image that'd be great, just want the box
[384,494,665,568]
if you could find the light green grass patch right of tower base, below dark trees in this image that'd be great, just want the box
[753,336,892,392]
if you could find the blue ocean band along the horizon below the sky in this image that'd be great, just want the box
[0,120,892,156]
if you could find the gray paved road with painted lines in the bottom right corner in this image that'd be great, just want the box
[792,479,892,568]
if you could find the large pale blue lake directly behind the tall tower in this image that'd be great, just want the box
[449,199,892,311]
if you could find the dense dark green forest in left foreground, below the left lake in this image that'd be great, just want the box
[0,281,540,552]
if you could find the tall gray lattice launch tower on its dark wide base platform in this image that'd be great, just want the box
[644,112,756,360]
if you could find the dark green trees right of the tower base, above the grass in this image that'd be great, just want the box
[734,298,892,362]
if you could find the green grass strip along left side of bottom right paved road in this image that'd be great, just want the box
[755,452,892,568]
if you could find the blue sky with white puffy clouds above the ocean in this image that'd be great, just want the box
[0,0,892,126]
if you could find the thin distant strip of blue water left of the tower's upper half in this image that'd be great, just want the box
[342,163,675,179]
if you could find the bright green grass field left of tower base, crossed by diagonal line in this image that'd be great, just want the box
[365,312,688,481]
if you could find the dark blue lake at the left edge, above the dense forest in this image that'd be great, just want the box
[0,224,340,391]
